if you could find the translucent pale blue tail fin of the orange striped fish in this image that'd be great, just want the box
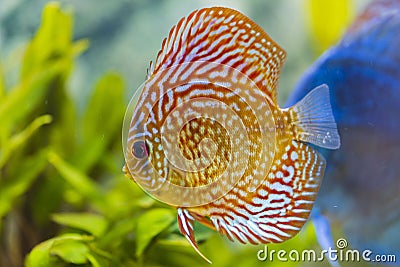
[289,84,340,149]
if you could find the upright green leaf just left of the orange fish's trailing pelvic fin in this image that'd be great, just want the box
[136,209,174,257]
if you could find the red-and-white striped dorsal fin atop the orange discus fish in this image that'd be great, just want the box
[148,7,286,101]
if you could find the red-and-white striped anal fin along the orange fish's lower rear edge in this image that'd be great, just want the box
[189,141,325,244]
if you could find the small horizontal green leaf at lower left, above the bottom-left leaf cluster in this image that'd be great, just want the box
[52,212,108,237]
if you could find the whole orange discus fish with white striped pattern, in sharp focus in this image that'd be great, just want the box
[123,7,340,261]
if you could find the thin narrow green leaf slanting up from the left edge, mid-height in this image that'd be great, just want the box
[0,115,52,168]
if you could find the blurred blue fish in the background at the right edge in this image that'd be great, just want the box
[287,0,400,264]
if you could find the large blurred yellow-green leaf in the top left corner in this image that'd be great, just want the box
[0,3,87,132]
